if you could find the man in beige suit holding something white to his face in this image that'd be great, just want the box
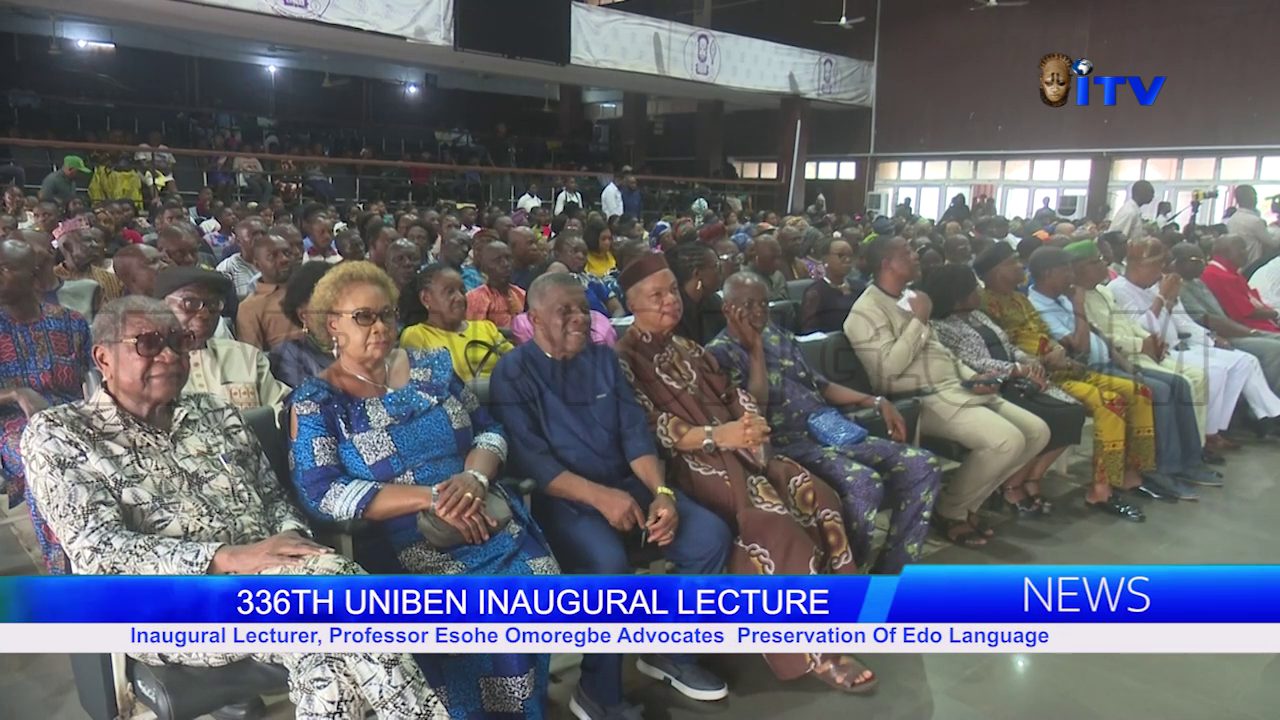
[845,236,1050,546]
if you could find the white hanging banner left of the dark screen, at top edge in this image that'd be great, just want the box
[183,0,453,47]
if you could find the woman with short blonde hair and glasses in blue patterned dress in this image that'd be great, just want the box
[289,261,558,717]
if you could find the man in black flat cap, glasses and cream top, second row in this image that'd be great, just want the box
[151,266,289,413]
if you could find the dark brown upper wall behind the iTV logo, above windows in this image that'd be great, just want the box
[876,0,1280,155]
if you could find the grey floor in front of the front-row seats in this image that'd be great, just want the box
[0,435,1280,720]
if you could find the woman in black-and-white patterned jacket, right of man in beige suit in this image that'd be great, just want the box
[923,264,1102,514]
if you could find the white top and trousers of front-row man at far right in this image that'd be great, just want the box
[1107,277,1280,434]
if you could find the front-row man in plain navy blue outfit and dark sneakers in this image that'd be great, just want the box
[490,273,730,720]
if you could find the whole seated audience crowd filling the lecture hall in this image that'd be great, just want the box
[0,162,1280,720]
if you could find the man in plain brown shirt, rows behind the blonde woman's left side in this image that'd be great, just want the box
[236,234,303,351]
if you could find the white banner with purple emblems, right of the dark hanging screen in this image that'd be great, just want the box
[570,3,874,106]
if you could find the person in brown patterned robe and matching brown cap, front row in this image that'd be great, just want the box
[617,255,877,692]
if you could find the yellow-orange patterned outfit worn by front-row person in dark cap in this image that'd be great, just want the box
[982,288,1156,487]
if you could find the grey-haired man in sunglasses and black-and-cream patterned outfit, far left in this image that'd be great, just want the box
[22,296,447,720]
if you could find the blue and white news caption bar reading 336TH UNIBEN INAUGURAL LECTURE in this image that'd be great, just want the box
[0,565,1280,653]
